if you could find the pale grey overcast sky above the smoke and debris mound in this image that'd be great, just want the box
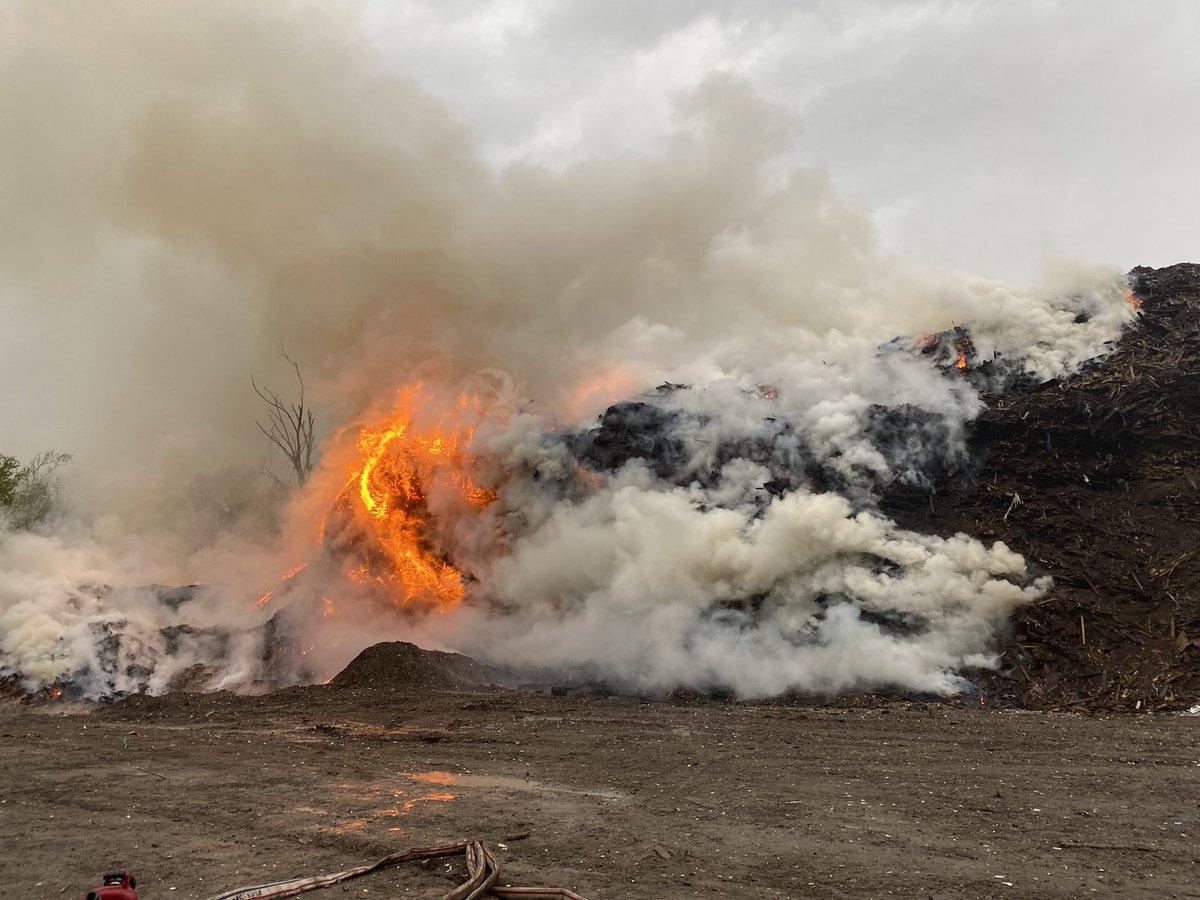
[365,0,1200,283]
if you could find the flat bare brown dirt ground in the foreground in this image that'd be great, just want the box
[0,685,1200,900]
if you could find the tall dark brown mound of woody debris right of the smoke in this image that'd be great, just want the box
[883,264,1200,709]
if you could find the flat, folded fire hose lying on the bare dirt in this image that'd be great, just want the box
[209,841,583,900]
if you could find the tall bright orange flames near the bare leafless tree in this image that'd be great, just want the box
[326,385,496,612]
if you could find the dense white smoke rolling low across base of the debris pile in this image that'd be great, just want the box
[439,480,1044,696]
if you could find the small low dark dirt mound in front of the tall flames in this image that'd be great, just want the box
[330,641,502,690]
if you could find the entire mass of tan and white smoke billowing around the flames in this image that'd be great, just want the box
[0,1,1133,695]
